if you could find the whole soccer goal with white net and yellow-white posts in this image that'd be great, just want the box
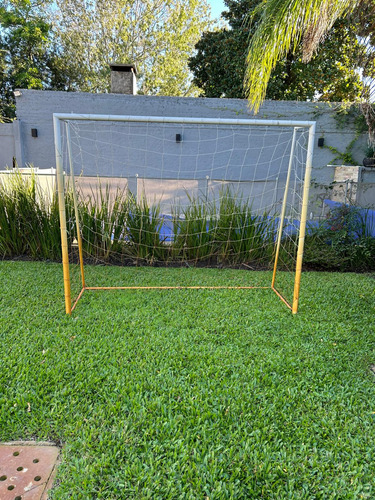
[53,113,315,314]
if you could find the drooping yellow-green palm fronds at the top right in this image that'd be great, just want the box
[245,0,375,117]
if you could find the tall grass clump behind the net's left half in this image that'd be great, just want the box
[79,184,173,265]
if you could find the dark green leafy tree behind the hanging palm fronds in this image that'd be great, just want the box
[189,0,362,101]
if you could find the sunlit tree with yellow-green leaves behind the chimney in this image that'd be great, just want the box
[54,0,209,95]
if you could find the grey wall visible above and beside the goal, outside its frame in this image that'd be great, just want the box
[17,90,366,178]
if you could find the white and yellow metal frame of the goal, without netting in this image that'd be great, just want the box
[53,113,316,315]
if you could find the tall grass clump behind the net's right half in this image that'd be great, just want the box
[173,188,275,265]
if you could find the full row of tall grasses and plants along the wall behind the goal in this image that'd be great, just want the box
[0,172,375,271]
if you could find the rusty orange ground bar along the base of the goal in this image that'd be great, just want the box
[71,285,293,312]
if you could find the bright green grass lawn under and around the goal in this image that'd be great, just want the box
[0,262,375,500]
